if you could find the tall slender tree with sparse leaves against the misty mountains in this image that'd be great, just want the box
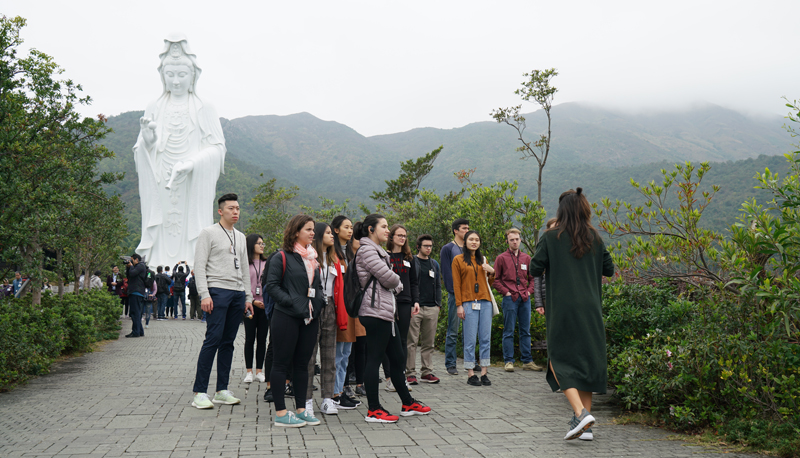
[491,68,558,242]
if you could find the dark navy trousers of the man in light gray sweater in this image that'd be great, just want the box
[193,288,245,393]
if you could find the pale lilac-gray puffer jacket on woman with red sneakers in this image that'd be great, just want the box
[355,237,403,321]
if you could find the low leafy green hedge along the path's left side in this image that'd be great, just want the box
[0,290,122,391]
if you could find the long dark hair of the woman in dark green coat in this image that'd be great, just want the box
[547,188,600,259]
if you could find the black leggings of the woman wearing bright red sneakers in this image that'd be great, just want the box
[360,316,414,410]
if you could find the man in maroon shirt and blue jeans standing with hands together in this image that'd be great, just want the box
[492,227,544,372]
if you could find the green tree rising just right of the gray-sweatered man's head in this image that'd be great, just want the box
[247,178,299,253]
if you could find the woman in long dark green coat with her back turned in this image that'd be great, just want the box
[531,188,614,440]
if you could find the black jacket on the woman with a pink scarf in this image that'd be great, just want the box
[266,253,325,318]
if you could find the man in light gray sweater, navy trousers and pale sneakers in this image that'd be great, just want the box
[192,194,253,409]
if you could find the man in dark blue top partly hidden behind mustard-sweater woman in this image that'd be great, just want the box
[439,218,469,375]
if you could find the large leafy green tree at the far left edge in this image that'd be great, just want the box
[0,16,120,304]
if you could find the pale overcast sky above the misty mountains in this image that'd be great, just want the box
[7,0,800,136]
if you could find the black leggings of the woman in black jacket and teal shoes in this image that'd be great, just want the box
[270,310,319,411]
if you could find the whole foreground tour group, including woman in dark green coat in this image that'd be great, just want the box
[186,188,613,439]
